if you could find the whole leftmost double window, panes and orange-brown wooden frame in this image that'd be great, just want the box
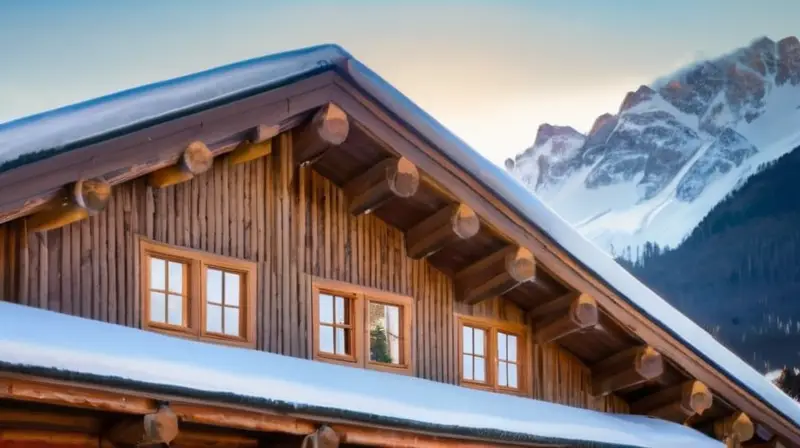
[140,239,256,347]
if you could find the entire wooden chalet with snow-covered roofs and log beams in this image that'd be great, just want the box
[0,46,800,448]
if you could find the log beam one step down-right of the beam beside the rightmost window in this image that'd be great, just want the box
[592,346,664,396]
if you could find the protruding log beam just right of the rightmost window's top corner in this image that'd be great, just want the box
[530,294,600,344]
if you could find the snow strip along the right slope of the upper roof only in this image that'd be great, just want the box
[346,58,800,427]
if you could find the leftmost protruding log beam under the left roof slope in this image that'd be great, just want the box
[27,179,111,232]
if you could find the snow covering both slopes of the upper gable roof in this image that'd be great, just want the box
[0,45,800,434]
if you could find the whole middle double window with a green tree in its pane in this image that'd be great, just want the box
[314,279,414,374]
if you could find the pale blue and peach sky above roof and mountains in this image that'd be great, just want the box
[0,0,800,163]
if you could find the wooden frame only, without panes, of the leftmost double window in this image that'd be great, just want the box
[138,236,257,348]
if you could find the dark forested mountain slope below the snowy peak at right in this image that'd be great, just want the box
[618,147,800,371]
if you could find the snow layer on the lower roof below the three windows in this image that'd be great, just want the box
[0,302,722,448]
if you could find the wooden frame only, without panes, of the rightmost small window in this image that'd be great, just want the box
[456,314,531,396]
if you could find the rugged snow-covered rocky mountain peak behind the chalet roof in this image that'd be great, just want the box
[506,37,800,255]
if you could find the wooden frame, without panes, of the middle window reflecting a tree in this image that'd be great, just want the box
[312,277,414,375]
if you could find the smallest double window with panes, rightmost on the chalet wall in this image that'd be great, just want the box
[459,316,527,394]
